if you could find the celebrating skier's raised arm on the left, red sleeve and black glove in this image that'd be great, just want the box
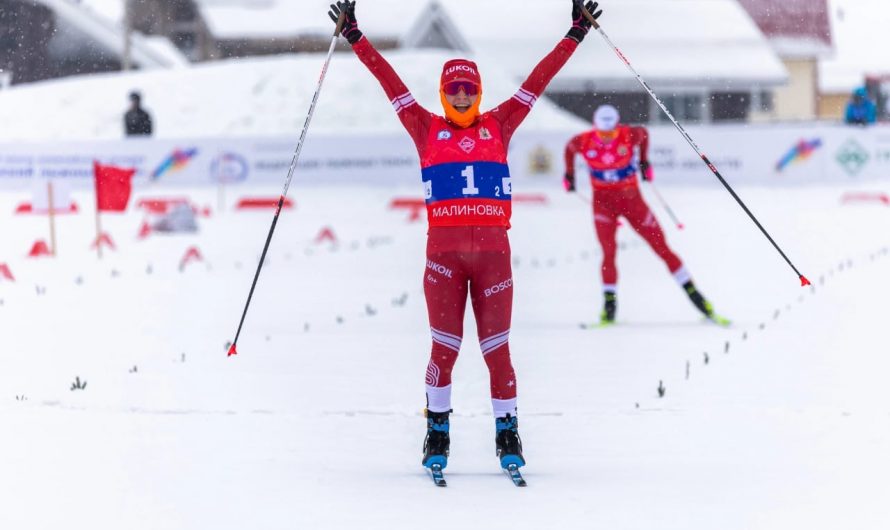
[328,0,432,147]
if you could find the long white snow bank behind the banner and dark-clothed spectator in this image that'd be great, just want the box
[0,50,585,141]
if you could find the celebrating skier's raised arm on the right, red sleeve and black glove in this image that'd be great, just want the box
[492,0,603,144]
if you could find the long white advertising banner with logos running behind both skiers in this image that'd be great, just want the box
[0,124,890,189]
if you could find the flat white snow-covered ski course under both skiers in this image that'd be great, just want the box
[0,179,890,530]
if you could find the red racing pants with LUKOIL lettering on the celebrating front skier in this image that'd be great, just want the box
[423,226,516,417]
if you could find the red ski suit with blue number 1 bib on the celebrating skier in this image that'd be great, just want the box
[353,38,578,417]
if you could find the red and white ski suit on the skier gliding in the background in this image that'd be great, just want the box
[565,125,689,292]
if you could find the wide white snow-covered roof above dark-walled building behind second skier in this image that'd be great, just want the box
[440,0,786,89]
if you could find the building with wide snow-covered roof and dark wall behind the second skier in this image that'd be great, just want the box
[435,0,787,123]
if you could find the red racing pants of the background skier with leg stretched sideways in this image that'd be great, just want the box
[593,185,685,286]
